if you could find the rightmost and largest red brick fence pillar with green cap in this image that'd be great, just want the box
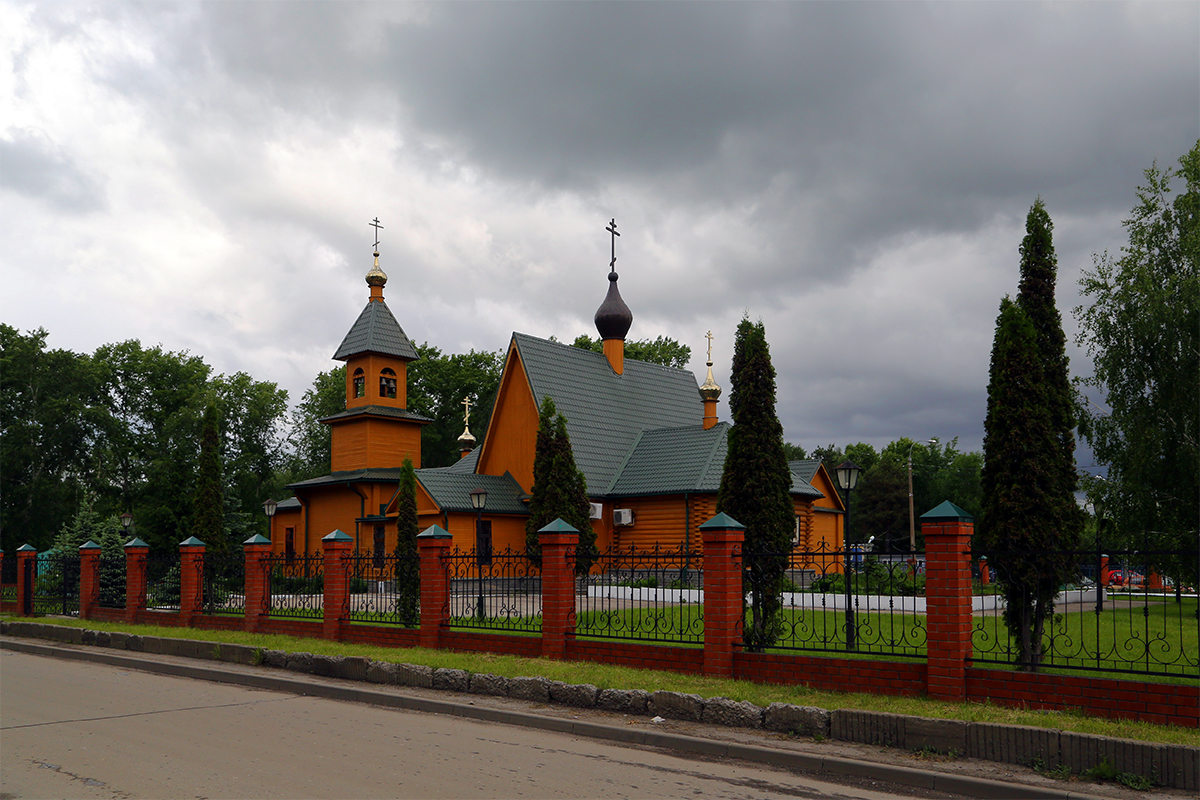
[920,500,974,700]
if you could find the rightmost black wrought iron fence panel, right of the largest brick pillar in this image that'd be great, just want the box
[971,551,1200,678]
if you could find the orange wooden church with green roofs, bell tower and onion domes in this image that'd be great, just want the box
[271,230,845,554]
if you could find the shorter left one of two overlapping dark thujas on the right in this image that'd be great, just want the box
[977,297,1070,669]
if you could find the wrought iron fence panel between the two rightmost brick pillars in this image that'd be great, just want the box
[742,547,926,657]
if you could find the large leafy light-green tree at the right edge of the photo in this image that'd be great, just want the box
[1075,140,1200,568]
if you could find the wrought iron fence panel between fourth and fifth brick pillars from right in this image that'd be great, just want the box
[342,552,421,627]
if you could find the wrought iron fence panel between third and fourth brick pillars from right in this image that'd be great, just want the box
[446,548,541,633]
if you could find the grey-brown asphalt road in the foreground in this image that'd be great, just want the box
[0,651,952,800]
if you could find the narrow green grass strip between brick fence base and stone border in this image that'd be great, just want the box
[12,618,1200,746]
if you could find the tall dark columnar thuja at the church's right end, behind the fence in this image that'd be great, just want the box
[716,318,796,650]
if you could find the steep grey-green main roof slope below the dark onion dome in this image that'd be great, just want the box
[512,333,703,493]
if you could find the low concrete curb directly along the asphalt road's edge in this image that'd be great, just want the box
[0,639,1097,800]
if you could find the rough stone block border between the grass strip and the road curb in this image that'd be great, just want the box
[0,621,1200,790]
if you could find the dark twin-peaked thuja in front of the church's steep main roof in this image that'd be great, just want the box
[526,397,596,575]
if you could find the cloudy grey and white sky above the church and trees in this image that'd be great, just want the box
[0,0,1200,467]
